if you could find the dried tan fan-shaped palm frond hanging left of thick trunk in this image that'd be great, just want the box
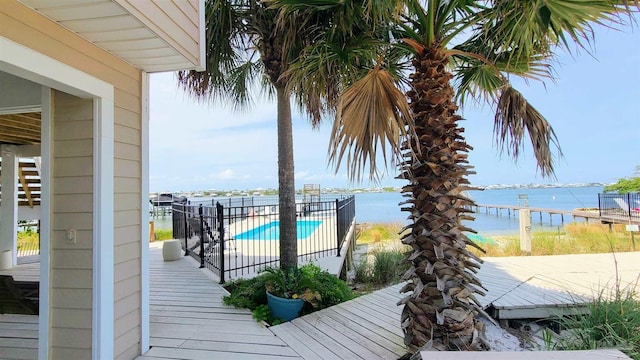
[329,67,414,182]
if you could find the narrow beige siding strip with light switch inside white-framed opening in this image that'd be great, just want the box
[48,91,93,359]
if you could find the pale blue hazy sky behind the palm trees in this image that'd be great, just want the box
[149,16,640,192]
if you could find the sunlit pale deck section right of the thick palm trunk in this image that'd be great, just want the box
[479,252,640,319]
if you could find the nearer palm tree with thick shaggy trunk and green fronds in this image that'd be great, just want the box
[322,0,638,356]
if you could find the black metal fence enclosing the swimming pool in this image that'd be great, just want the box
[173,196,355,283]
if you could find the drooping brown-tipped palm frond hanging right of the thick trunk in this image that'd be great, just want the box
[493,86,562,177]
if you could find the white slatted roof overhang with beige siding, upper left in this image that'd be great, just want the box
[19,0,205,72]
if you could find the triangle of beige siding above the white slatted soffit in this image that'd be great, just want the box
[115,0,204,70]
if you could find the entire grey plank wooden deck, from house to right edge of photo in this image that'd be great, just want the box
[0,248,640,360]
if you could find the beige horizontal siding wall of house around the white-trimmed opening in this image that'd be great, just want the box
[0,0,146,359]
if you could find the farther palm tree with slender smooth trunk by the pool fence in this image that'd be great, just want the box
[178,0,392,268]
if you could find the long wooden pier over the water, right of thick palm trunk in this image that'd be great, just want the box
[471,204,640,225]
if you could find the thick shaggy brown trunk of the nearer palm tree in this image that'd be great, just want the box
[401,44,485,354]
